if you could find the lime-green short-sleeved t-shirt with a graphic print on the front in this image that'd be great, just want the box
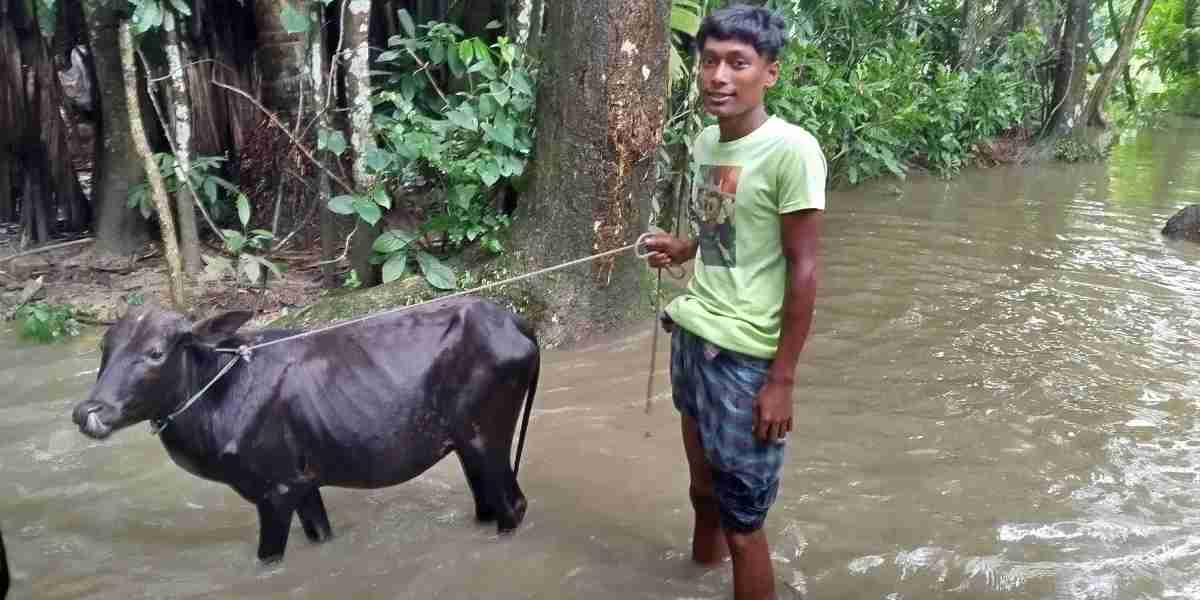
[667,116,826,359]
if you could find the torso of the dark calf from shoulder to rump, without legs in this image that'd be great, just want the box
[259,299,539,487]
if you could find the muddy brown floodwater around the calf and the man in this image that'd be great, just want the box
[0,121,1200,600]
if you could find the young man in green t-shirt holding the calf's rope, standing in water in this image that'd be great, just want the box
[646,5,826,600]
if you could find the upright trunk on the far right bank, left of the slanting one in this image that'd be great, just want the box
[1049,0,1092,137]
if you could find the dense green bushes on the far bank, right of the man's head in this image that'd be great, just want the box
[767,34,1039,184]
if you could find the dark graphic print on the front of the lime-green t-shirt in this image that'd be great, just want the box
[691,164,742,269]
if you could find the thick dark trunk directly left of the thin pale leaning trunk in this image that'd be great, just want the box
[84,0,149,256]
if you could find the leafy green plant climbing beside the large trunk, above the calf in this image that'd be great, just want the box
[318,10,535,289]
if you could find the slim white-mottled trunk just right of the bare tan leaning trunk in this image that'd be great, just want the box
[162,11,204,275]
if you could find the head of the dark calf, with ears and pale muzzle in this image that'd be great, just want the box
[72,306,252,439]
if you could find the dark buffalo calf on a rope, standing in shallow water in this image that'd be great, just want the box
[73,299,541,562]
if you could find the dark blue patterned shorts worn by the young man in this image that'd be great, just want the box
[671,325,785,533]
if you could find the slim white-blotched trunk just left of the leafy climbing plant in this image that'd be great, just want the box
[342,0,382,287]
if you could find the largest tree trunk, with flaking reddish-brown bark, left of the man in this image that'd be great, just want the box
[511,0,670,346]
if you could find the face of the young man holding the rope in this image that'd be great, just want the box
[700,38,779,120]
